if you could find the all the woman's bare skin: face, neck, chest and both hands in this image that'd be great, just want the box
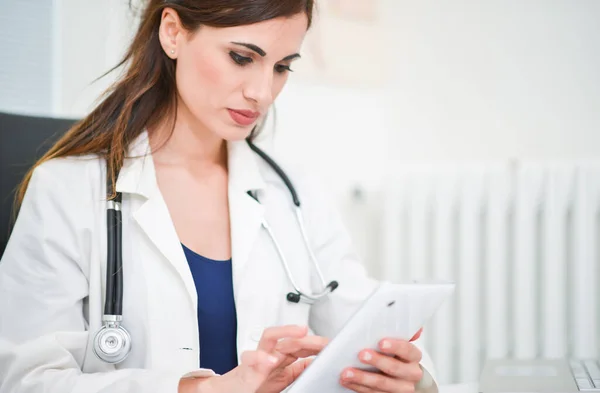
[155,8,422,393]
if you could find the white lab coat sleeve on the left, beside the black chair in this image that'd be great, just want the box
[0,162,205,393]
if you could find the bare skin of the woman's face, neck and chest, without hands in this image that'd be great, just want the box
[150,9,307,260]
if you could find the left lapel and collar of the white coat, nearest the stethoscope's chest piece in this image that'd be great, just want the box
[117,132,197,309]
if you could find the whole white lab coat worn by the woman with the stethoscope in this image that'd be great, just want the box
[0,133,437,393]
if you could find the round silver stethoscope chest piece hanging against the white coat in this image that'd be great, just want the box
[94,323,131,364]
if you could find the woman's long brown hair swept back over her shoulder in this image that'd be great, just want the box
[15,0,314,205]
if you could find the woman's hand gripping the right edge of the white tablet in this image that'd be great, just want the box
[340,331,423,393]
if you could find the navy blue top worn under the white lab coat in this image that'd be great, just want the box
[183,242,238,374]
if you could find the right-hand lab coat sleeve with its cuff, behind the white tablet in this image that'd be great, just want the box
[301,175,438,393]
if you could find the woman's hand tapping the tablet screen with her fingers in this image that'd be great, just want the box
[188,326,327,393]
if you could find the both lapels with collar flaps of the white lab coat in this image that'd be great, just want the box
[116,132,266,310]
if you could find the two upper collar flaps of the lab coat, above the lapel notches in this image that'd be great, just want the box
[116,131,266,199]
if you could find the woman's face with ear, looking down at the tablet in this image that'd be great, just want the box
[161,9,307,140]
